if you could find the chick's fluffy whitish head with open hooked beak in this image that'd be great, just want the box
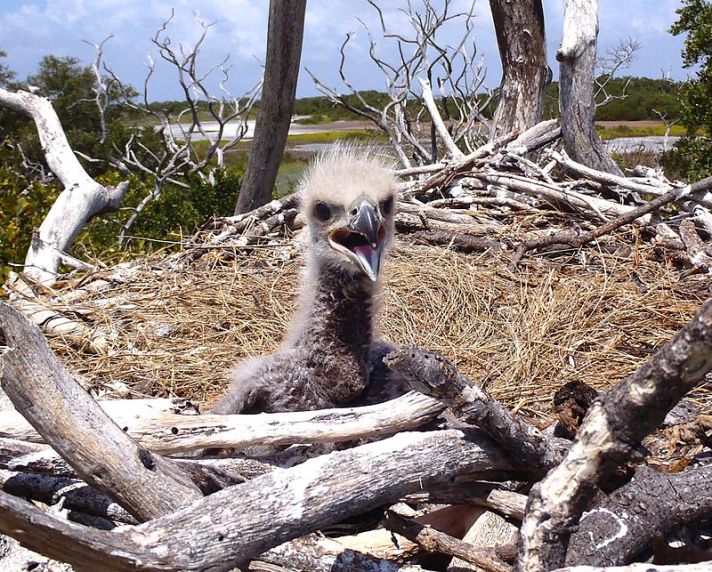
[299,145,398,281]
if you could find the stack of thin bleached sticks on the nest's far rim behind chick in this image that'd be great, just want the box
[189,120,712,274]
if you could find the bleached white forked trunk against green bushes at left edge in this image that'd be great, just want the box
[0,88,128,282]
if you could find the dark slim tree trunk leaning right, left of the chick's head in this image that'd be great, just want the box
[235,0,307,214]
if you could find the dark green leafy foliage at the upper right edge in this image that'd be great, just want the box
[662,0,712,181]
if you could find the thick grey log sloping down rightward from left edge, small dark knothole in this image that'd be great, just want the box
[0,303,202,520]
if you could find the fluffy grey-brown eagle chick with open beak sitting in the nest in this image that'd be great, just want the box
[212,145,397,414]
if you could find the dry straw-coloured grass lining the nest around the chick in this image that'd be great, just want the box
[47,235,710,417]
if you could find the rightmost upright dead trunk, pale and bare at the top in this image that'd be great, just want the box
[556,0,622,175]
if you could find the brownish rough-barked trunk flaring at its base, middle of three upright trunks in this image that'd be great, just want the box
[490,0,551,140]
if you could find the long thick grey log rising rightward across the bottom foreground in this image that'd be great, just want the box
[0,430,509,571]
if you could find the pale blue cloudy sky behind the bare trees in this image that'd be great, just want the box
[0,0,689,100]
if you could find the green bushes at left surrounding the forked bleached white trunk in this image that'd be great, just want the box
[0,52,244,283]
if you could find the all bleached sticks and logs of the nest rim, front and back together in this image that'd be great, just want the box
[0,118,712,571]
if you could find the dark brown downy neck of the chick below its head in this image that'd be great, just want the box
[293,260,377,358]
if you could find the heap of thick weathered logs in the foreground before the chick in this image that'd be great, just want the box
[0,290,712,571]
